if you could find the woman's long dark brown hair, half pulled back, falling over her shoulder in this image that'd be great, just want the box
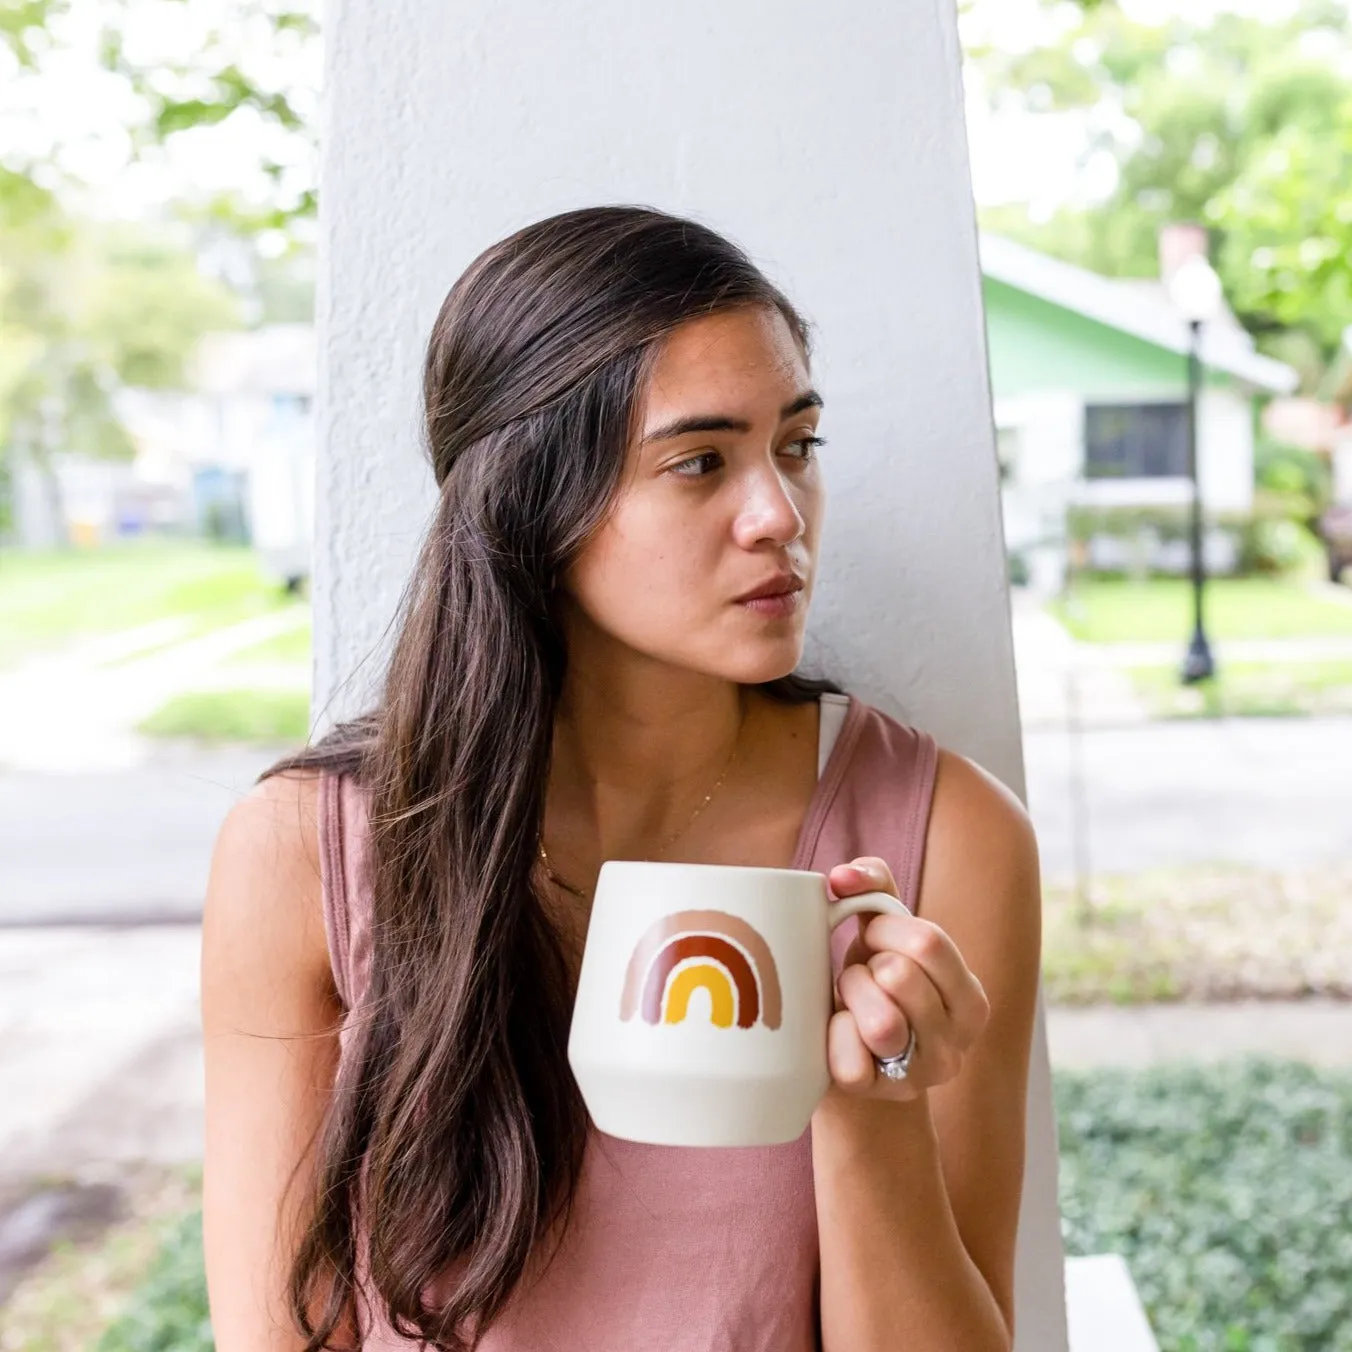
[268,206,838,1352]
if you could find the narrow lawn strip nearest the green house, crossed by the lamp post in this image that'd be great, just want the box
[1052,577,1352,645]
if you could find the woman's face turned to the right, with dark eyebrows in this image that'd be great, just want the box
[562,307,823,683]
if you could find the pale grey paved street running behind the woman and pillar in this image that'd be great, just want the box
[0,718,1352,925]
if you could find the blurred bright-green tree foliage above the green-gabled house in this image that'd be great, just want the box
[969,0,1352,381]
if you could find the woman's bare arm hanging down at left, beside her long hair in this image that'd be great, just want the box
[201,776,342,1352]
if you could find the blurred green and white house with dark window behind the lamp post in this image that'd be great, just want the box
[980,227,1298,589]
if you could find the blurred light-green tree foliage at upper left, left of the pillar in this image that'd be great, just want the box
[0,0,305,538]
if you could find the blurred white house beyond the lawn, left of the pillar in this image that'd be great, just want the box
[15,323,315,580]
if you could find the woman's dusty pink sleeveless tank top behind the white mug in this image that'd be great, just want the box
[319,695,937,1352]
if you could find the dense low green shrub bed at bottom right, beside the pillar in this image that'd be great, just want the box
[1056,1059,1352,1352]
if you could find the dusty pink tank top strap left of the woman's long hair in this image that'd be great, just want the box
[318,771,372,1010]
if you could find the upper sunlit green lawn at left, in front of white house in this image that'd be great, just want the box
[0,541,296,664]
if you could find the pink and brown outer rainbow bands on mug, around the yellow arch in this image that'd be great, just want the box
[619,911,783,1028]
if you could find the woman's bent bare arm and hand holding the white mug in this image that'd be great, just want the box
[813,753,1041,1352]
